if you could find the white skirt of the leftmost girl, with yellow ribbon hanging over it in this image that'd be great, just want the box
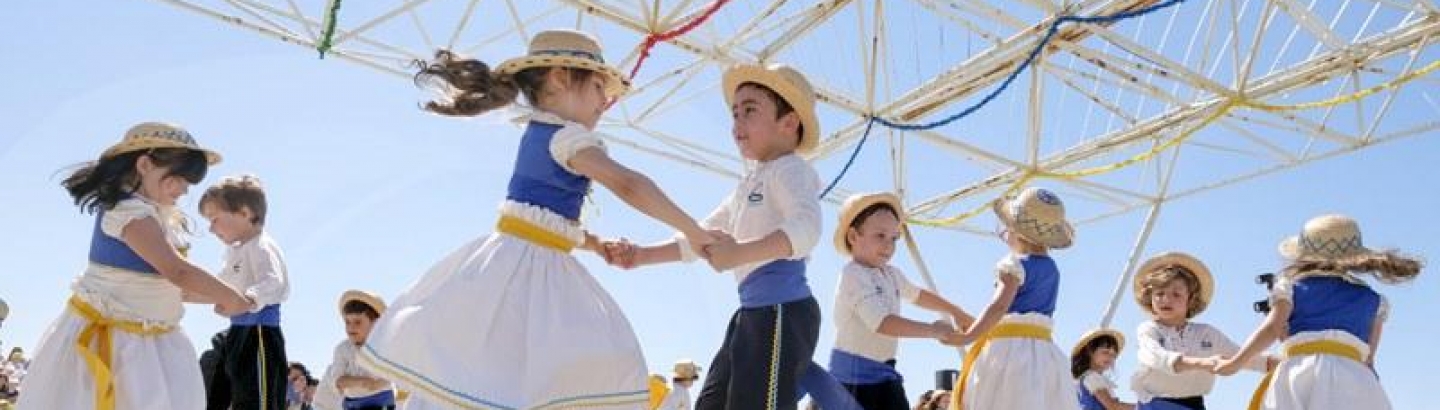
[19,266,204,410]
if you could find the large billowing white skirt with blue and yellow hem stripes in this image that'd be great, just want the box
[359,203,648,409]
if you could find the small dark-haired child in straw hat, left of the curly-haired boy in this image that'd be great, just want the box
[1070,329,1135,410]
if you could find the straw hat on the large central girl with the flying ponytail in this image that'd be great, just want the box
[495,29,629,98]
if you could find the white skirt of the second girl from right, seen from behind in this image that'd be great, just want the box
[960,314,1080,410]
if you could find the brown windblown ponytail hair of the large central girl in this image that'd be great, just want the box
[415,50,595,117]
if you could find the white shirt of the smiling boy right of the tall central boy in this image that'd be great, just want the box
[835,260,920,363]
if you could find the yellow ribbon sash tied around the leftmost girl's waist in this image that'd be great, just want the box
[69,296,171,410]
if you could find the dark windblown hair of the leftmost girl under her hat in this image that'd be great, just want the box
[60,148,210,213]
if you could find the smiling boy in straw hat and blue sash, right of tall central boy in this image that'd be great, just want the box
[829,193,973,410]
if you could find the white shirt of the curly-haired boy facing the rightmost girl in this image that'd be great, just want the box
[1130,321,1266,403]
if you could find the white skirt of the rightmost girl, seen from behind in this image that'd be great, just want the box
[1263,329,1390,410]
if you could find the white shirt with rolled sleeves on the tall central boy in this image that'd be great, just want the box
[675,154,821,282]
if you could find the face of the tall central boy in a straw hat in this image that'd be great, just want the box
[730,85,799,161]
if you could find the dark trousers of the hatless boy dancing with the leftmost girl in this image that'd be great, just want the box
[206,325,289,410]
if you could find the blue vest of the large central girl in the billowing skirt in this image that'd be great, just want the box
[505,121,590,220]
